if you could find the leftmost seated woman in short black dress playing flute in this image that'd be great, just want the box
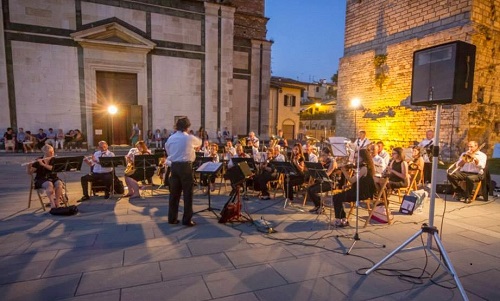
[27,144,63,208]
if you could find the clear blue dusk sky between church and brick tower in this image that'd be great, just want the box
[265,0,346,82]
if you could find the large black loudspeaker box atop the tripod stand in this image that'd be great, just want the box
[411,41,476,106]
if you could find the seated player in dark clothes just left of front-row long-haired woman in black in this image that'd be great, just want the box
[307,147,337,213]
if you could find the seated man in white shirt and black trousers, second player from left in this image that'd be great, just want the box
[80,141,115,202]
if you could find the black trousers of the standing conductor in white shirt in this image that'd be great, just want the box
[168,162,194,224]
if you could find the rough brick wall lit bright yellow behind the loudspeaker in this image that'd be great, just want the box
[336,0,500,159]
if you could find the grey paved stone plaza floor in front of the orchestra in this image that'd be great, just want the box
[0,154,500,301]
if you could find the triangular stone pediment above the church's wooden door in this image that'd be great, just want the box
[71,22,156,52]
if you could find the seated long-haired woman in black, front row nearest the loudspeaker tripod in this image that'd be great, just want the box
[332,149,375,227]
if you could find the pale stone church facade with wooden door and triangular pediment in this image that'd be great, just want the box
[0,0,271,145]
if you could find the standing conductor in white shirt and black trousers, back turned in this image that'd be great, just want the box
[165,117,201,227]
